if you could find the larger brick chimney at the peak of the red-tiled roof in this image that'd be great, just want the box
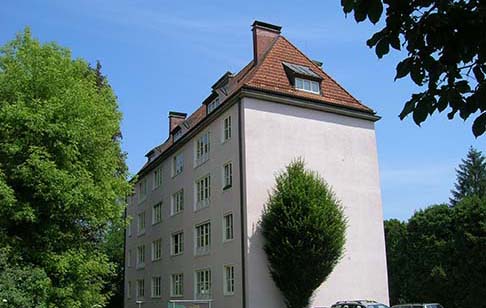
[252,20,282,64]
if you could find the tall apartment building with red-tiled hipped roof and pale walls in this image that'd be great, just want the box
[125,21,388,308]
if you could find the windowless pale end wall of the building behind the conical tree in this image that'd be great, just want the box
[242,98,388,308]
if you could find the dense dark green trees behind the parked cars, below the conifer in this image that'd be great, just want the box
[385,196,486,308]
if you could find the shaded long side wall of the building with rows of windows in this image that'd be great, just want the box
[125,105,242,308]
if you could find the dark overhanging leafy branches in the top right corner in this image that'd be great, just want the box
[341,0,486,136]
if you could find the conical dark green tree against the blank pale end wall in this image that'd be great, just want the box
[261,160,346,308]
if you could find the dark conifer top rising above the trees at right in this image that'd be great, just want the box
[450,147,486,205]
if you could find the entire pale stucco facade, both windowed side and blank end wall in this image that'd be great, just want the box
[125,94,388,308]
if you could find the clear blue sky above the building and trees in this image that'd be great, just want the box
[0,0,486,219]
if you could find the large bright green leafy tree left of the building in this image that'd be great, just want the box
[0,29,130,308]
